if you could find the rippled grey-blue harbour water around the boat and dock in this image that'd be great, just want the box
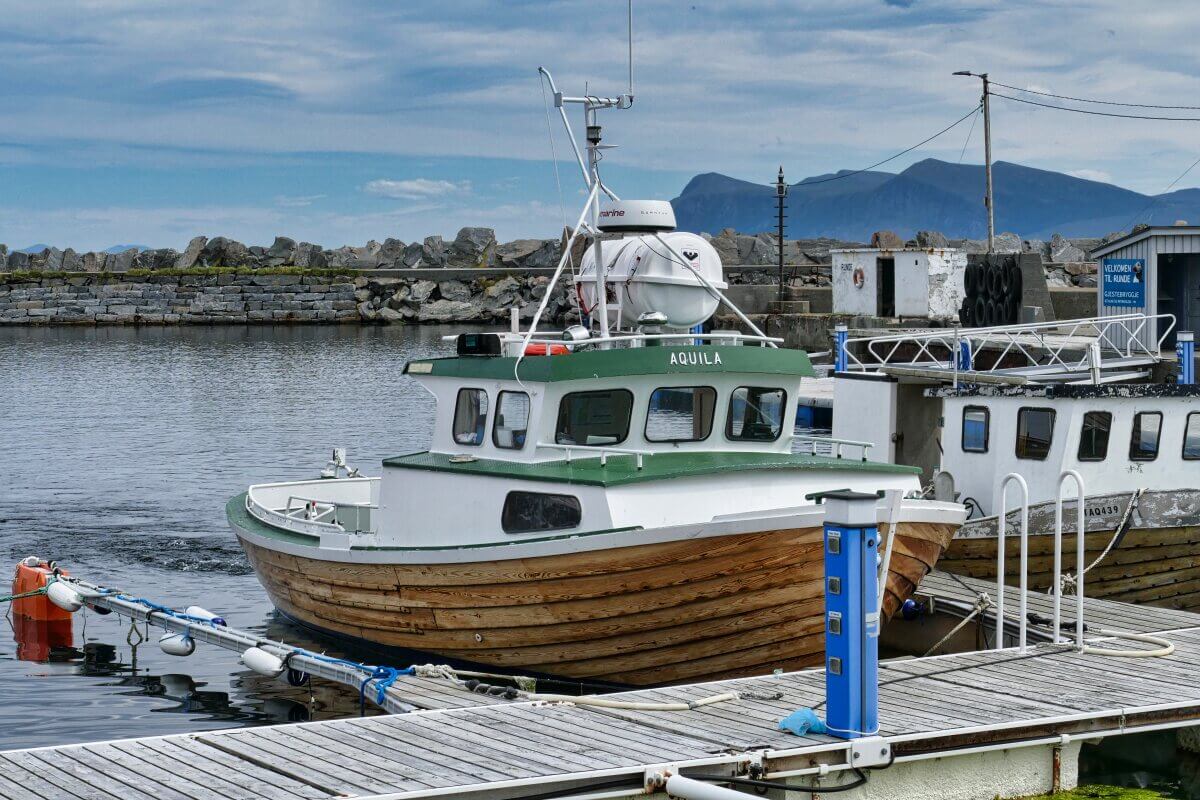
[0,326,1200,798]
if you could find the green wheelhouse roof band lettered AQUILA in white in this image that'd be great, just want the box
[404,345,816,383]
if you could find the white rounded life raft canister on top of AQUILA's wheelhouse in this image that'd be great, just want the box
[575,231,728,330]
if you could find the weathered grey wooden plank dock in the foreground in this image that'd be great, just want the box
[7,573,1200,800]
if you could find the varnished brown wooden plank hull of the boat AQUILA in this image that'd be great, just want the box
[239,523,954,685]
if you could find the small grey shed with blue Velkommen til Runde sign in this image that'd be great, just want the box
[1092,224,1200,347]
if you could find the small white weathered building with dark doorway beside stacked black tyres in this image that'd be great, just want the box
[830,247,967,320]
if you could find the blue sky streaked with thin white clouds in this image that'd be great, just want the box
[0,0,1200,249]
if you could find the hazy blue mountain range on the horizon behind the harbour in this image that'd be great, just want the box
[672,158,1200,241]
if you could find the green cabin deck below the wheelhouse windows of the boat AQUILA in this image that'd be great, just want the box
[383,451,920,487]
